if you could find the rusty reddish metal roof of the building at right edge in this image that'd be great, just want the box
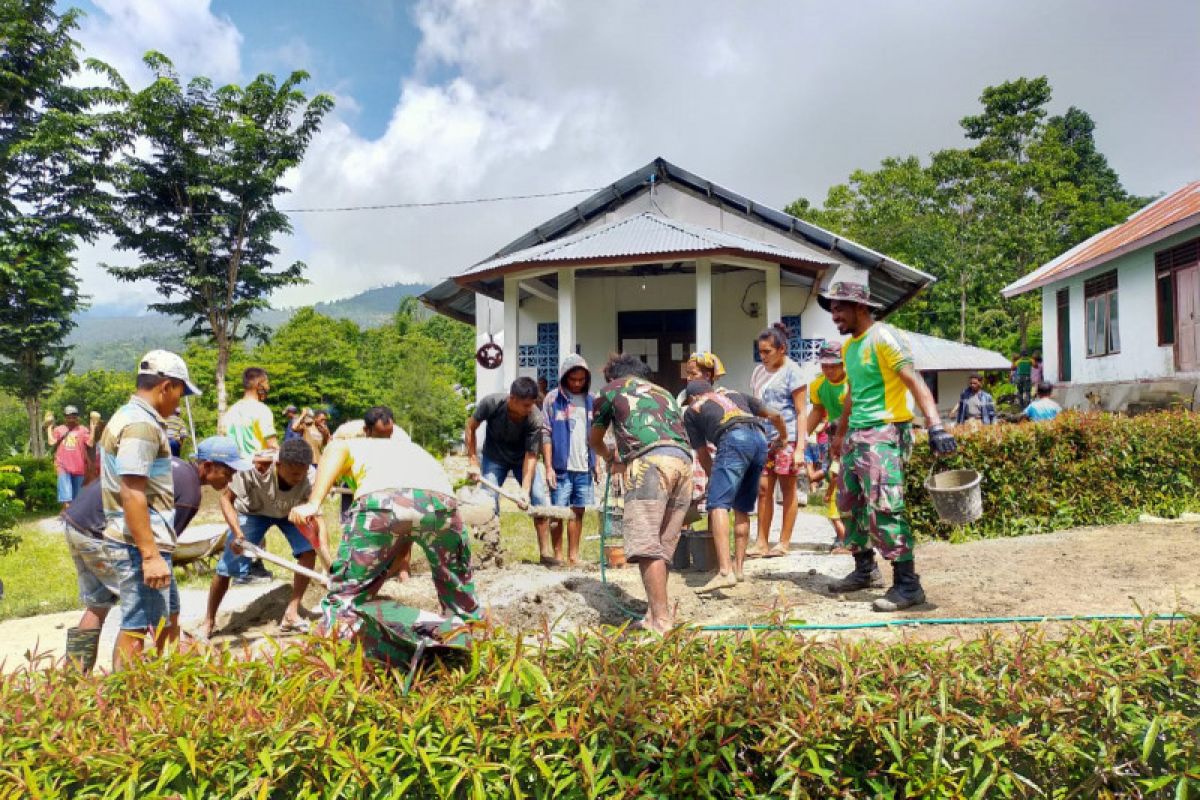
[1001,181,1200,297]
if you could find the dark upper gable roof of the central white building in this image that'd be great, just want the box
[421,158,936,323]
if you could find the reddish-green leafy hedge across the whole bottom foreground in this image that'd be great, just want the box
[0,618,1200,798]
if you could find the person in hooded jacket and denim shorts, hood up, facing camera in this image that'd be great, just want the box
[541,355,596,566]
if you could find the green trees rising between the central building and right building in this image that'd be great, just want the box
[788,77,1146,353]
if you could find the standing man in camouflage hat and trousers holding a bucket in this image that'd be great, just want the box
[818,282,956,612]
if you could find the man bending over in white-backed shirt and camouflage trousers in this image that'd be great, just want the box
[290,407,479,664]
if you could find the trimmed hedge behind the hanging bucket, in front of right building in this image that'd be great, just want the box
[906,411,1200,541]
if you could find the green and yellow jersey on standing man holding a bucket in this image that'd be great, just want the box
[841,323,912,431]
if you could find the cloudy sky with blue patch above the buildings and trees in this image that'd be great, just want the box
[65,0,1200,309]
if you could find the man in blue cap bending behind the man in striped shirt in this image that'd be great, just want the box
[62,437,251,672]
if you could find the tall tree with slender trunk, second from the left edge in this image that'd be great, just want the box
[107,53,334,416]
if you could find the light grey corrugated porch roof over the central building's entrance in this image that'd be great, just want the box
[458,212,838,277]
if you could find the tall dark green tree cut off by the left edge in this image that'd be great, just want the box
[0,0,125,456]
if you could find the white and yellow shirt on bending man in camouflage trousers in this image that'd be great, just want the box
[330,439,454,498]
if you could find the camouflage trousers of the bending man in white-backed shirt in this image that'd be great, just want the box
[319,489,479,664]
